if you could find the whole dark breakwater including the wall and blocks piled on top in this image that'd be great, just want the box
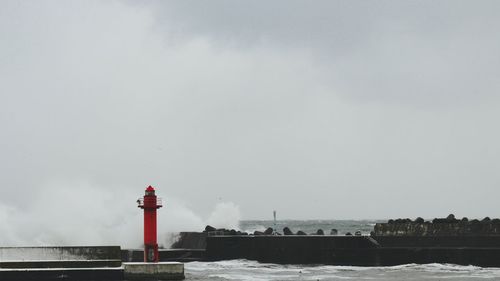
[169,215,500,267]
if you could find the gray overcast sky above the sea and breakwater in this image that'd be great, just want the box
[0,1,500,243]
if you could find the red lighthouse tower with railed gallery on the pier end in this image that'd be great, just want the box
[137,186,163,262]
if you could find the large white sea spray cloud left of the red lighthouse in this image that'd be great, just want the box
[0,181,142,246]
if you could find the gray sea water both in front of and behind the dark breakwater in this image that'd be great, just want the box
[185,220,500,281]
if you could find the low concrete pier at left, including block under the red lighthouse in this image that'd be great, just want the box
[0,246,184,281]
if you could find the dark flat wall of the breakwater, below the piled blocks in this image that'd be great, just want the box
[206,233,500,267]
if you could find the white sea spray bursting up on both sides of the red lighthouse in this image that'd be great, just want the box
[0,181,240,248]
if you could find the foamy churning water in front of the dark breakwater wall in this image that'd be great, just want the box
[185,260,500,281]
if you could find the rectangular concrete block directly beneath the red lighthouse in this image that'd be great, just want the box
[123,262,185,281]
